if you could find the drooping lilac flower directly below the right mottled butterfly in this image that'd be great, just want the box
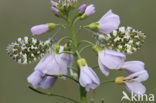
[98,49,126,76]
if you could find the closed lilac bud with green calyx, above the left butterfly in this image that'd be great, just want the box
[31,23,58,35]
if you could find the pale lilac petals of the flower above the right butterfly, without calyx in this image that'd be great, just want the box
[98,10,120,34]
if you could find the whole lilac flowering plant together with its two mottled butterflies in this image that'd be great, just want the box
[7,0,149,103]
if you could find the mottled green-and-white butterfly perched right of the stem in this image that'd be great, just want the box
[95,27,146,54]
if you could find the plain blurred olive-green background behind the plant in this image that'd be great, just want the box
[0,0,156,103]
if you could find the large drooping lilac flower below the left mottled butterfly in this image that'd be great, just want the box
[27,46,73,89]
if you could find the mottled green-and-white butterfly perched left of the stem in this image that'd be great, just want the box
[7,36,51,64]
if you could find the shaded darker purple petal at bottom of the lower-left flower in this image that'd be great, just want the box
[40,76,56,89]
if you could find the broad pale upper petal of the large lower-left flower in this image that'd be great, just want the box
[35,54,67,75]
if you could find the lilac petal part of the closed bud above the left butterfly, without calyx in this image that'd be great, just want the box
[31,24,49,35]
